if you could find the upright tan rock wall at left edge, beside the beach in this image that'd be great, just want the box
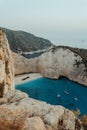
[0,30,14,97]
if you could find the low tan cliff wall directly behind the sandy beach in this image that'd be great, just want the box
[12,53,38,75]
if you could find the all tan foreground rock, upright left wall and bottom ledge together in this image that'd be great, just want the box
[0,30,83,130]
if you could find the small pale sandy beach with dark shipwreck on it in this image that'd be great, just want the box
[15,73,42,85]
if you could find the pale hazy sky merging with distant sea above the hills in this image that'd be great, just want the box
[0,0,87,48]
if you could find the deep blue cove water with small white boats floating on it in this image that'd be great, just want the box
[16,77,87,114]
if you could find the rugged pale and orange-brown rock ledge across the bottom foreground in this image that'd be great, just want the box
[0,90,82,130]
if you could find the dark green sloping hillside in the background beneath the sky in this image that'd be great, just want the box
[3,28,52,52]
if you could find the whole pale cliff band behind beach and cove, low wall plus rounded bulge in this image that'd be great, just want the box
[13,46,87,86]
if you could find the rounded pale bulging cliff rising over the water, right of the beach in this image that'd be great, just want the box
[38,47,87,85]
